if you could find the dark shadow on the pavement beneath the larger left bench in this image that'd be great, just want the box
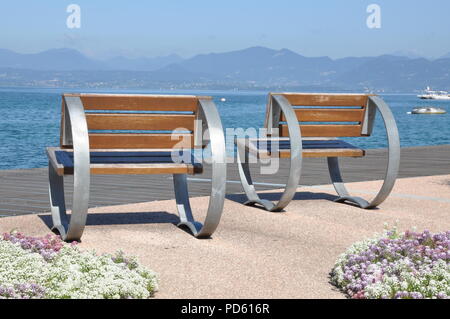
[38,212,180,229]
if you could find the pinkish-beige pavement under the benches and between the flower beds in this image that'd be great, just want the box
[0,175,450,298]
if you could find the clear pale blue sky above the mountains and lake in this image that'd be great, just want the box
[0,0,450,58]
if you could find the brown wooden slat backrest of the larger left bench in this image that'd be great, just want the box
[61,94,210,149]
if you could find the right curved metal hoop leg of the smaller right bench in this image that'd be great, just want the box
[328,97,400,209]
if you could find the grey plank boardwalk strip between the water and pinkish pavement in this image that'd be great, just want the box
[0,145,450,217]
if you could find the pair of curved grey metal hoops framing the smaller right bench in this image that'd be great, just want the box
[237,94,400,212]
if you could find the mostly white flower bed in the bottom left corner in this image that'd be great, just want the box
[0,232,157,299]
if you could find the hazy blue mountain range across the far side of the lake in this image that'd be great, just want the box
[0,47,450,92]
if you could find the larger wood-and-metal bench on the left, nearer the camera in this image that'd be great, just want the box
[47,94,226,240]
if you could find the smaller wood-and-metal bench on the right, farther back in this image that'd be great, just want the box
[236,93,400,211]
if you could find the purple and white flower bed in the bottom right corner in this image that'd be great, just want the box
[331,229,450,299]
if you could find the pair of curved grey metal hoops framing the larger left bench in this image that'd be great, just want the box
[47,96,226,241]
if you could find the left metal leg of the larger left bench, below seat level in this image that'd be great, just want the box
[48,163,89,241]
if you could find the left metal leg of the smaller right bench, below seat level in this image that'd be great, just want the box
[237,145,301,212]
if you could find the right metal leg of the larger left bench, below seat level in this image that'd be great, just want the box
[173,174,225,238]
